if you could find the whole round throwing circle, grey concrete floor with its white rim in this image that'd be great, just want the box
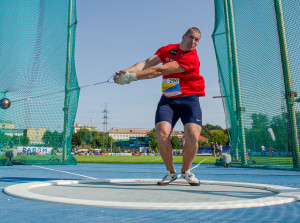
[4,179,300,210]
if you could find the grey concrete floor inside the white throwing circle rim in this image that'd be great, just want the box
[30,182,274,203]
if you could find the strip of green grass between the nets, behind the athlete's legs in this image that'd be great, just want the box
[74,156,217,164]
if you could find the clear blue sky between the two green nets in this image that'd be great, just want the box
[75,0,226,131]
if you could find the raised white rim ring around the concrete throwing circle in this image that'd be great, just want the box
[4,179,300,210]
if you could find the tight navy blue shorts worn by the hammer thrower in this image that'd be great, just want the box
[155,95,202,128]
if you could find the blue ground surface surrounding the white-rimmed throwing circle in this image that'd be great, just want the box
[0,164,300,222]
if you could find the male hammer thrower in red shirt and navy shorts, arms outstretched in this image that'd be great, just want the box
[114,27,205,186]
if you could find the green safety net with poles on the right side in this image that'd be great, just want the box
[212,0,300,169]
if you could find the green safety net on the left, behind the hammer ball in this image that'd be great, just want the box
[0,0,79,165]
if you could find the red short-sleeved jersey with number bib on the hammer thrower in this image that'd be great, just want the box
[155,44,205,98]
